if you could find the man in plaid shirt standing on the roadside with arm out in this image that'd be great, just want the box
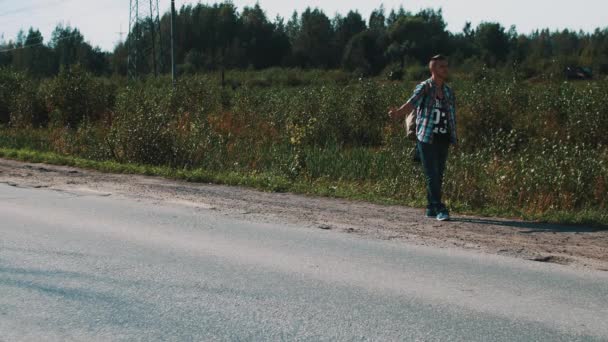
[389,55,457,221]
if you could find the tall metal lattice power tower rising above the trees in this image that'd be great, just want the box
[127,0,164,78]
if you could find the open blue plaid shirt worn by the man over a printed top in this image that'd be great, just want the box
[408,78,458,144]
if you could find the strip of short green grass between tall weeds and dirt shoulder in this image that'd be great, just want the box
[0,148,608,229]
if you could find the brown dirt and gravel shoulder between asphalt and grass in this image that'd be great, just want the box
[0,159,608,270]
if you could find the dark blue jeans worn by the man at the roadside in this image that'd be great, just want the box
[418,141,450,210]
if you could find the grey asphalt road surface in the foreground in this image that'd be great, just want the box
[0,184,608,341]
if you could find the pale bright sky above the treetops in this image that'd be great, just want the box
[0,0,608,50]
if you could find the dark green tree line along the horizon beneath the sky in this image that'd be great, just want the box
[0,2,608,77]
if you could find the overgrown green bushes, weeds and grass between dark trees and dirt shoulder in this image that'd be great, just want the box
[0,67,608,224]
